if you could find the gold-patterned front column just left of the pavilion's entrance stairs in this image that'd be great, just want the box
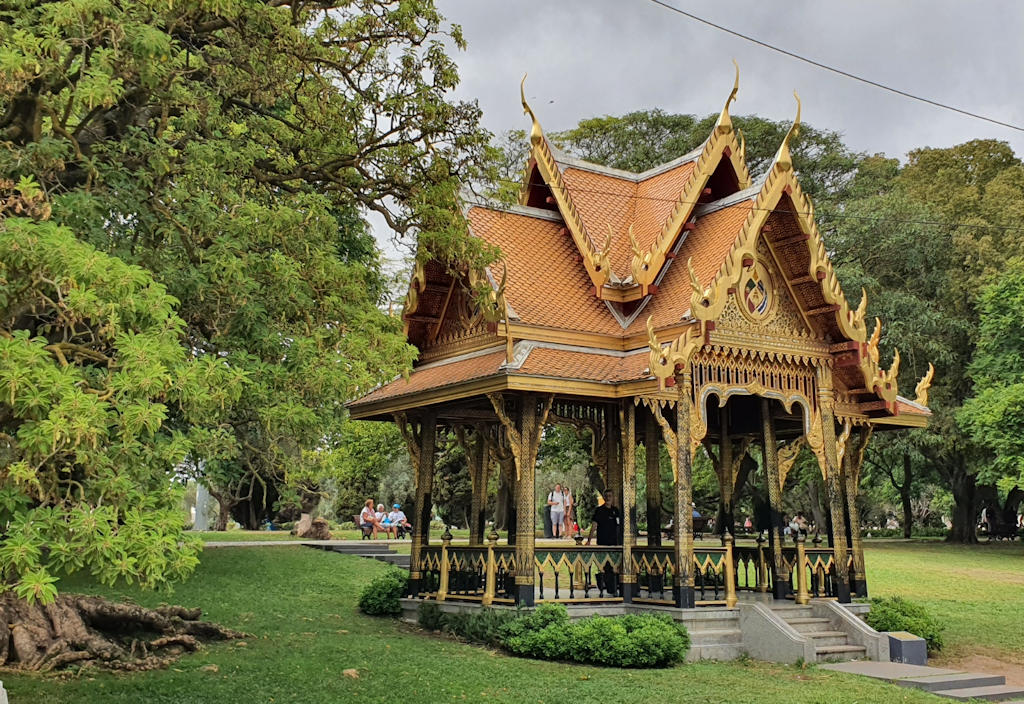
[672,376,694,609]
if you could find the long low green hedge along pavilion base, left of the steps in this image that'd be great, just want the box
[420,604,690,667]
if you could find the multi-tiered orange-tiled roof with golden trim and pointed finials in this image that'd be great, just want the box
[349,71,930,426]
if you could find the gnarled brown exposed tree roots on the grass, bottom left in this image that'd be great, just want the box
[0,593,245,672]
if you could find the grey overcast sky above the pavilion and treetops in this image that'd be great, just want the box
[375,0,1024,266]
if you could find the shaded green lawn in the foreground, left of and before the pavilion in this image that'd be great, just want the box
[3,546,962,704]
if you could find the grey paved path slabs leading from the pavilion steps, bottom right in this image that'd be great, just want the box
[821,661,1024,704]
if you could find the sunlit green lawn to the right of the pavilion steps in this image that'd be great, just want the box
[864,540,1024,665]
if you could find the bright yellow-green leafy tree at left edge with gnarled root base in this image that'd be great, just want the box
[0,202,242,669]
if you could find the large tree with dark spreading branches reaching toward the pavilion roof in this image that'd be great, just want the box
[0,0,495,527]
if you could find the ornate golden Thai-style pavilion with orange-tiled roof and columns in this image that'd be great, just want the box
[348,75,931,607]
